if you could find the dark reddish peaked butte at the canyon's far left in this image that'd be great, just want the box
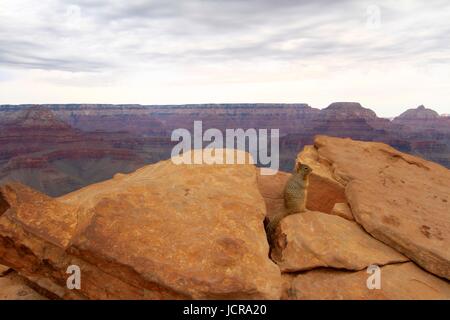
[0,106,148,195]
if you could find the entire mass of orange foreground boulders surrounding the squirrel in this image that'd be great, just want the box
[0,136,450,299]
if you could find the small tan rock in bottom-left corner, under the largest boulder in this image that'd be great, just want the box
[0,273,45,300]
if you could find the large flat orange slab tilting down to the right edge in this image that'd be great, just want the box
[300,136,450,279]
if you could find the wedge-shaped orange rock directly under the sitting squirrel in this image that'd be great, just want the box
[272,212,408,272]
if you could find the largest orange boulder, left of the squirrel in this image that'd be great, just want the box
[0,150,281,299]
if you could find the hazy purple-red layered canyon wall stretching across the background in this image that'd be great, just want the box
[0,102,450,196]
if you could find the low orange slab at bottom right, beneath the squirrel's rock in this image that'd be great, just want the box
[283,262,450,300]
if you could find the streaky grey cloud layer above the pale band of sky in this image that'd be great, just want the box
[0,0,450,72]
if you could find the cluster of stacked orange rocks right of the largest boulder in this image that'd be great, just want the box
[266,136,450,300]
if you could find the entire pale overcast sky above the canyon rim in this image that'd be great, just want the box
[0,0,450,116]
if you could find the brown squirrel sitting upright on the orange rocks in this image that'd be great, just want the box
[266,162,312,243]
